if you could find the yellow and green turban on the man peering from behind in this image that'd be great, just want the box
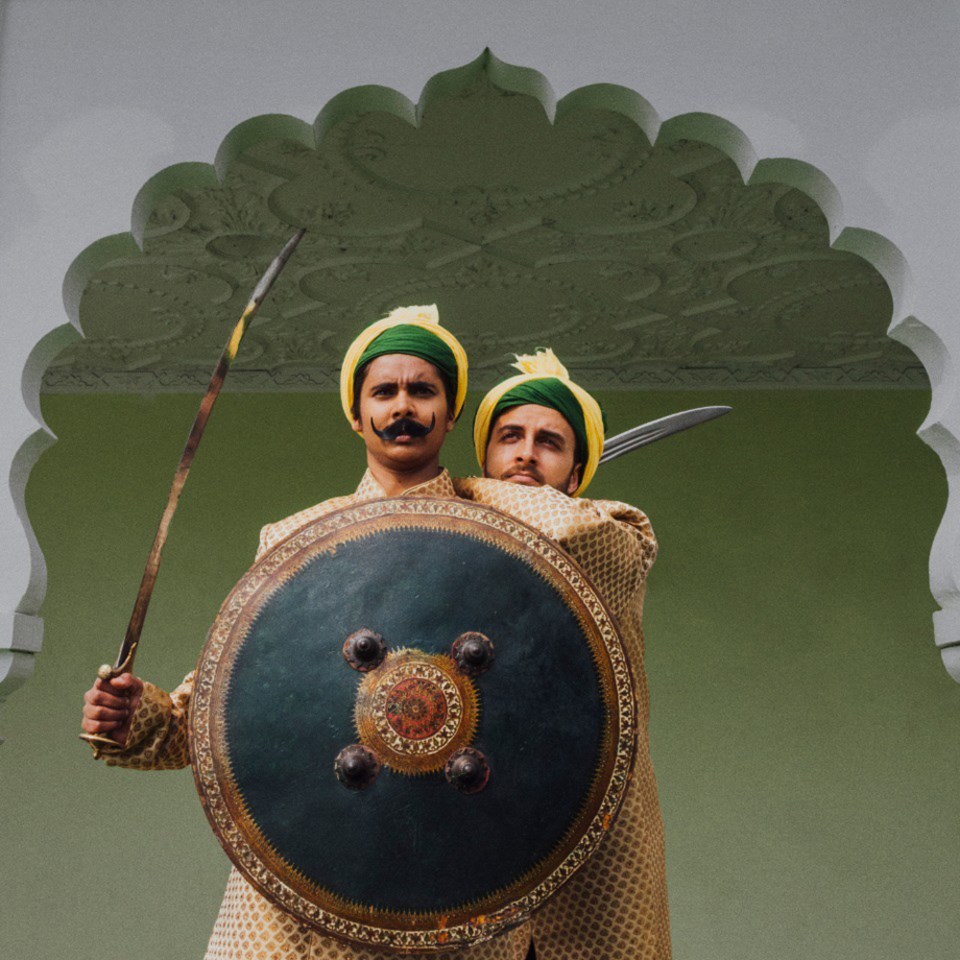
[473,348,606,497]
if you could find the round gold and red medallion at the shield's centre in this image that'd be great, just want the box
[354,650,477,774]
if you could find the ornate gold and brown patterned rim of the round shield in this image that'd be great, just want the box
[191,497,636,953]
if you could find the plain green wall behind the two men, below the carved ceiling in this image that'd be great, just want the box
[0,391,960,960]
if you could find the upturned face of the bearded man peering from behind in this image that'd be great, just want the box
[483,403,582,494]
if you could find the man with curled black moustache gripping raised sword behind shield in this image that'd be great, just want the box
[83,306,526,960]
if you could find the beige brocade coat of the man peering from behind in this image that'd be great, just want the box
[454,477,671,960]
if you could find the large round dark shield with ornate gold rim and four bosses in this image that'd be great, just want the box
[191,498,635,952]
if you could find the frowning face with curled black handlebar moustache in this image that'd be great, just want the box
[353,353,453,471]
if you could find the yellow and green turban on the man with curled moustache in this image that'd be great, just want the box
[340,304,467,424]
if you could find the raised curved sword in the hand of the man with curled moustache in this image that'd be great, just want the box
[80,228,306,757]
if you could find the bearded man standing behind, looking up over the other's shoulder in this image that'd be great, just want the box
[454,350,671,960]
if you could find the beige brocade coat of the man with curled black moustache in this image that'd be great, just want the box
[98,470,530,960]
